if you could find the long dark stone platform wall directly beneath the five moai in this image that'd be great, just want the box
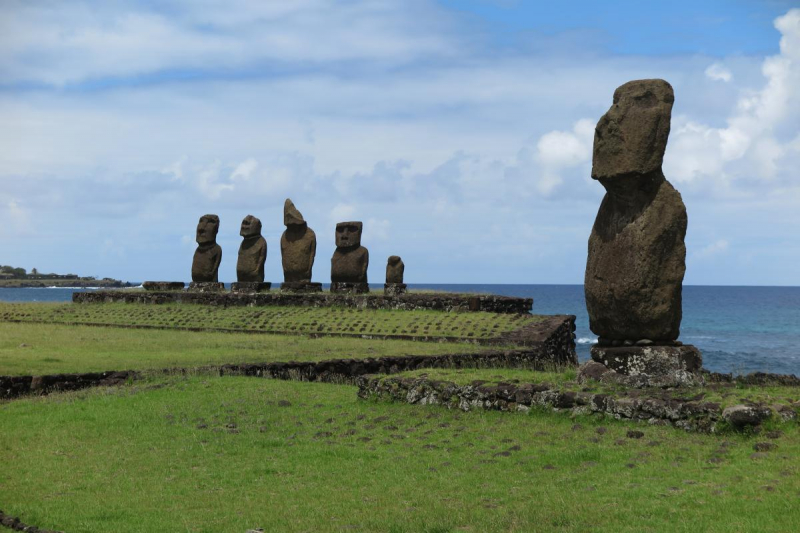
[72,291,533,314]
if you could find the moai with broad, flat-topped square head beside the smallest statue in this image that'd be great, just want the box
[331,222,369,294]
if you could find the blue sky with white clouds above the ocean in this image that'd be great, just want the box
[0,0,800,286]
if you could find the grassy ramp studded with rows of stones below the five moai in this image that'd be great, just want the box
[0,303,541,340]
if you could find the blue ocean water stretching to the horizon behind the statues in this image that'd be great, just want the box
[0,284,800,375]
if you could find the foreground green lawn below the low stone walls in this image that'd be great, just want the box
[0,377,800,533]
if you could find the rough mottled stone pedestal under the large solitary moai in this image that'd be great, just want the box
[591,344,703,376]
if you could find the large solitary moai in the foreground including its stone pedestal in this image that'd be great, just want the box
[584,79,702,382]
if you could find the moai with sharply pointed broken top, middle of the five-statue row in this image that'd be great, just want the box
[281,198,317,283]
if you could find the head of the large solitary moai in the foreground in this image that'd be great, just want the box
[592,80,675,181]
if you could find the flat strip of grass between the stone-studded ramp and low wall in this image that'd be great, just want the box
[0,322,488,374]
